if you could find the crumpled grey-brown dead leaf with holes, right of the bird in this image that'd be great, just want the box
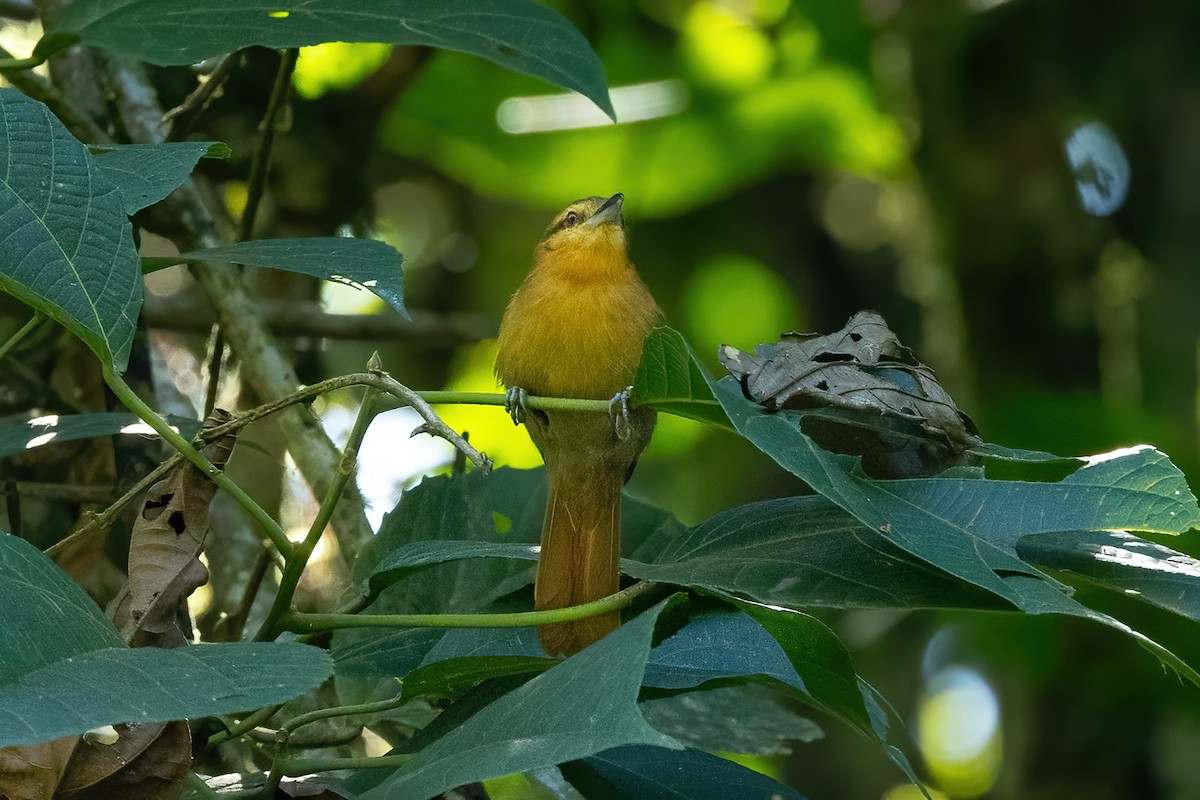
[720,311,980,477]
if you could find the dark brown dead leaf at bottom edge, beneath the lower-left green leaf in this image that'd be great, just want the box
[56,722,192,800]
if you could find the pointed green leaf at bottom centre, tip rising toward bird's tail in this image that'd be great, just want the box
[362,600,679,800]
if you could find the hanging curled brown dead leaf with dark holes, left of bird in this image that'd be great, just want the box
[108,409,236,648]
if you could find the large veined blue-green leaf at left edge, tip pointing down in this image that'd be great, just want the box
[0,89,142,372]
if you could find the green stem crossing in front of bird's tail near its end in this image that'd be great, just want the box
[287,581,655,633]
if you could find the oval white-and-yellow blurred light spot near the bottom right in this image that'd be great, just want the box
[917,664,1003,798]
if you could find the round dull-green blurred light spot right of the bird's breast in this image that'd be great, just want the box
[684,255,805,362]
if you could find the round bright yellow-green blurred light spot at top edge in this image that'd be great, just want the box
[680,0,775,91]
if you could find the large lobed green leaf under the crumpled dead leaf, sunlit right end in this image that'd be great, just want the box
[713,378,1200,610]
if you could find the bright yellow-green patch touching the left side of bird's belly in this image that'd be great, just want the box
[437,339,541,469]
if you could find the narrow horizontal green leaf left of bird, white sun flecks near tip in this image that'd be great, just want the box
[162,236,409,319]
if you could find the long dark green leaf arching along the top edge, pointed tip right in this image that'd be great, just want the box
[47,0,613,116]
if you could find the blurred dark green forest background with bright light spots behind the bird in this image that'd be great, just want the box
[7,0,1200,800]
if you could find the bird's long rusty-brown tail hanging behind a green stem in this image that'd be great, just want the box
[534,463,625,655]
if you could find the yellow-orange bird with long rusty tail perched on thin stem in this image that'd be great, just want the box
[496,193,662,656]
